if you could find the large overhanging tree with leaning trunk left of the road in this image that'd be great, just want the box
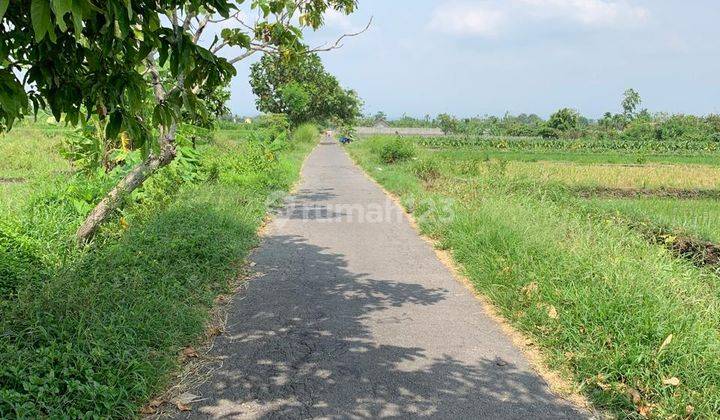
[0,0,356,242]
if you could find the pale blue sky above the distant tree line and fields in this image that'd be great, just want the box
[225,0,720,117]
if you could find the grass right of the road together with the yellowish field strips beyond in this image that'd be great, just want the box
[350,137,720,418]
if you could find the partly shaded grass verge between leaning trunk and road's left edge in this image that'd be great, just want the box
[0,122,318,418]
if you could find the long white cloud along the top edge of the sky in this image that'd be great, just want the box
[428,0,649,38]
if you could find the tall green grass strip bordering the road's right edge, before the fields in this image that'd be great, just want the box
[350,139,720,418]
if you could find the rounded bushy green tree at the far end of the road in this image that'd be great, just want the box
[250,54,361,125]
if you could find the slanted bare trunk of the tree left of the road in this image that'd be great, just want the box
[75,128,176,245]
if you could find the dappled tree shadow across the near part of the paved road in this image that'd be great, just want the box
[189,236,583,418]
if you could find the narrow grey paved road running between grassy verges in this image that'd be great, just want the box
[189,139,585,419]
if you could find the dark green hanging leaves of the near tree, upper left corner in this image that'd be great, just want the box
[0,0,235,141]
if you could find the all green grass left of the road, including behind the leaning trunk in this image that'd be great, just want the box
[0,121,318,418]
